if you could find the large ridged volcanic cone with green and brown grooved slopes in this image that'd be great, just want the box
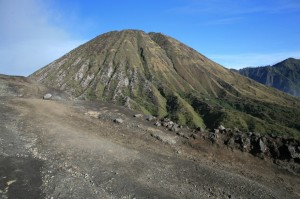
[31,30,300,136]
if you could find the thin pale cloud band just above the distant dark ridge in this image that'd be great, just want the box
[208,51,300,69]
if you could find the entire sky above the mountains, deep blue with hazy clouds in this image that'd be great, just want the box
[0,0,300,75]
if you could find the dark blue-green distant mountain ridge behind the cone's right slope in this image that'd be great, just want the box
[238,58,300,97]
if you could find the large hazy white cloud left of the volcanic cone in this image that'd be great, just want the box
[0,0,83,75]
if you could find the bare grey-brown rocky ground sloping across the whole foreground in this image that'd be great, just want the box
[0,76,300,199]
